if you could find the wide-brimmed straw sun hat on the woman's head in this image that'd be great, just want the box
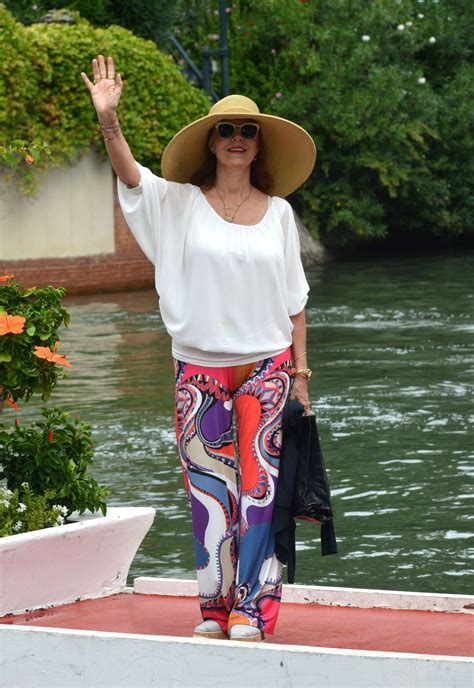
[161,95,316,196]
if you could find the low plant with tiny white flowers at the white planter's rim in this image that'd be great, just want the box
[0,483,67,537]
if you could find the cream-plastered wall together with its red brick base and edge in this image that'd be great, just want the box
[0,153,154,294]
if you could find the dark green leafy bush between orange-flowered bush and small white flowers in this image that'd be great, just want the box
[0,408,110,515]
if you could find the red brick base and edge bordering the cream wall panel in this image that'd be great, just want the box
[0,179,154,294]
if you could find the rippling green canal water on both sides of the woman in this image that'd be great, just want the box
[12,253,474,593]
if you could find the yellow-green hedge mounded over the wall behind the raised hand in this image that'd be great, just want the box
[0,5,210,191]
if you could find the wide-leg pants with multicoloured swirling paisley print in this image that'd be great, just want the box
[175,349,291,634]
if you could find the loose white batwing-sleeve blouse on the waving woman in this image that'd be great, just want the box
[118,163,309,366]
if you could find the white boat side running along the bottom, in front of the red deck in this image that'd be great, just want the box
[0,625,473,688]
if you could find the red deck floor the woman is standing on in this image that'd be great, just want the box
[0,593,474,656]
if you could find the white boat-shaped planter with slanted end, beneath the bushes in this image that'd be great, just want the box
[0,507,155,617]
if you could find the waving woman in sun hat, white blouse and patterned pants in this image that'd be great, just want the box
[82,55,316,641]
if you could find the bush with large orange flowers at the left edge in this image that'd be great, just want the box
[0,275,69,402]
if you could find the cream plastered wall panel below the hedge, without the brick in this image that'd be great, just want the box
[0,152,115,260]
